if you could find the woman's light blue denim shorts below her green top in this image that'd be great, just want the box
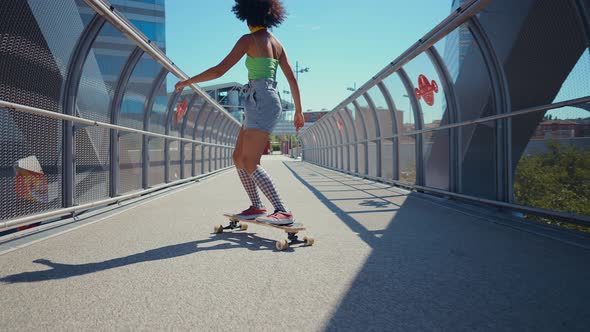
[243,79,283,134]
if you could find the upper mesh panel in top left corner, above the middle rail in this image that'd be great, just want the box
[0,1,87,112]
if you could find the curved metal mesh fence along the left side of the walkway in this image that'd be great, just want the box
[0,0,240,231]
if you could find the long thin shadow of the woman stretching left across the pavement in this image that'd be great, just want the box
[0,233,292,283]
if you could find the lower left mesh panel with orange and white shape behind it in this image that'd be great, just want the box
[0,108,62,220]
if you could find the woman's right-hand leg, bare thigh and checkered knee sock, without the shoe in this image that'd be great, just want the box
[242,129,287,212]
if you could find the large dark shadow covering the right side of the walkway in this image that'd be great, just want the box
[286,163,590,331]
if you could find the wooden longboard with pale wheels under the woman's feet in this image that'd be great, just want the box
[220,213,315,251]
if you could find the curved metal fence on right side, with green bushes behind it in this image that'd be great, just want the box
[301,0,590,226]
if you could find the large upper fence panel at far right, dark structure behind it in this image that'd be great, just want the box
[480,0,590,110]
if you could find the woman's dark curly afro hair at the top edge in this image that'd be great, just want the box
[232,0,287,28]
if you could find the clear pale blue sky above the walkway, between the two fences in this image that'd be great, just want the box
[166,0,452,111]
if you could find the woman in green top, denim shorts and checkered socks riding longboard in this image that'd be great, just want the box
[176,0,305,225]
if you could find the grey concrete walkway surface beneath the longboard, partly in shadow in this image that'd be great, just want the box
[0,156,590,331]
